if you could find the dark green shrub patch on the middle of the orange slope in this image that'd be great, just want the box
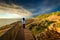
[29,20,54,34]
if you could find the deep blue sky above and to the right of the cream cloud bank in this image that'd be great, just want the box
[0,0,60,16]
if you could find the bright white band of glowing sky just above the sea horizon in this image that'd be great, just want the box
[0,13,31,18]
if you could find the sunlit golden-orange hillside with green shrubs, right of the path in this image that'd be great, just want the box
[27,11,60,40]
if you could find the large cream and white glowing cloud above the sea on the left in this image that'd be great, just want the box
[0,3,32,18]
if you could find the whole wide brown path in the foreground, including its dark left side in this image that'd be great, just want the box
[0,22,34,40]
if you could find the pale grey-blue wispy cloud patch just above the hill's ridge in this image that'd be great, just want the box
[30,6,56,16]
